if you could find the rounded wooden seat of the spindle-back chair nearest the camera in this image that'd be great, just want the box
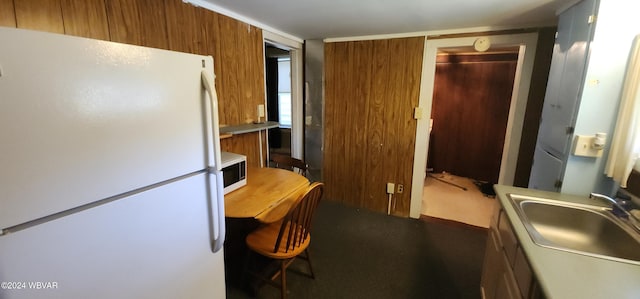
[246,220,311,259]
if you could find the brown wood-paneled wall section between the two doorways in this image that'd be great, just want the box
[323,37,424,216]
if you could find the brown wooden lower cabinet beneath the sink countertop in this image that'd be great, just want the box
[480,202,545,299]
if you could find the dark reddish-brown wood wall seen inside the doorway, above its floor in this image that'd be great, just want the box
[428,48,518,183]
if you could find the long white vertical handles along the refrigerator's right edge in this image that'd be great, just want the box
[201,70,225,252]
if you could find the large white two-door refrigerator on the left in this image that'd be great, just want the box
[0,27,225,299]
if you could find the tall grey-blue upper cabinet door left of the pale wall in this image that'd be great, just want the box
[538,0,596,157]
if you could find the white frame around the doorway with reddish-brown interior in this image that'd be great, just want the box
[409,32,538,218]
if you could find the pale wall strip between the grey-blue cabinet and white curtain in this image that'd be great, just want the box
[561,0,640,195]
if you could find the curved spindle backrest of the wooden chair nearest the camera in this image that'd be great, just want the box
[273,182,324,253]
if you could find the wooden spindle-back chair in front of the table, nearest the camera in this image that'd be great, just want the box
[246,182,324,299]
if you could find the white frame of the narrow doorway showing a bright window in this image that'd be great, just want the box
[262,30,304,160]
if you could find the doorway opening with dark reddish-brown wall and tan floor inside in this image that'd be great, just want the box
[421,47,519,228]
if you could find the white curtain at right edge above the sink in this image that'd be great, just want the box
[605,34,640,188]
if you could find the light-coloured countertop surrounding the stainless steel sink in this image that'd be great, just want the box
[495,185,640,299]
